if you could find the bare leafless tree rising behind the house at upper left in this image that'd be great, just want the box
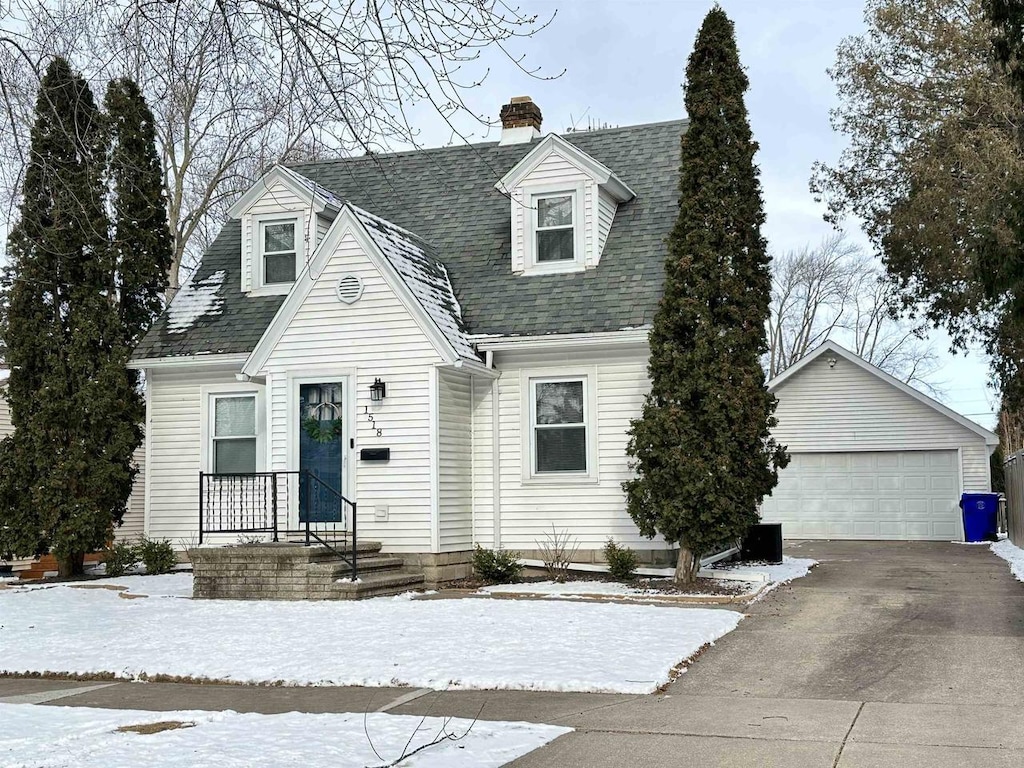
[0,0,550,290]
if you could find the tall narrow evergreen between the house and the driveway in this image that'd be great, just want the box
[623,6,788,582]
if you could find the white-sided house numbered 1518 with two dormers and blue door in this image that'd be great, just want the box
[133,98,999,577]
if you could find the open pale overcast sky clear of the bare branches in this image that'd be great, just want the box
[415,0,994,427]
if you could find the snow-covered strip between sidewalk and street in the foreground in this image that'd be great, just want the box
[0,705,571,768]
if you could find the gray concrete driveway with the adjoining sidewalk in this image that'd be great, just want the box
[0,542,1024,768]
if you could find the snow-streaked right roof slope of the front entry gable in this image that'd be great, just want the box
[351,206,479,359]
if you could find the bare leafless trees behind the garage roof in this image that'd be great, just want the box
[766,233,939,393]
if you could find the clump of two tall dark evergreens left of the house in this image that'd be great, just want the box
[0,58,169,574]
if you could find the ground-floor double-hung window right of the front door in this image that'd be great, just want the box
[529,377,590,475]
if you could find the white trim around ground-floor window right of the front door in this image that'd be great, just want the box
[519,368,600,485]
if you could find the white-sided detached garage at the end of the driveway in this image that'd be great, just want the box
[761,341,998,541]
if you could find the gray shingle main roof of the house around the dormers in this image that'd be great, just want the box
[135,121,685,358]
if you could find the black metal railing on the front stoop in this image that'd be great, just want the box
[199,470,358,581]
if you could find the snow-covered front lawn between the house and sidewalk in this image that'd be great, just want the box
[0,574,742,693]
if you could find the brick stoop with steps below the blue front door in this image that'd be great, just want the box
[189,542,424,600]
